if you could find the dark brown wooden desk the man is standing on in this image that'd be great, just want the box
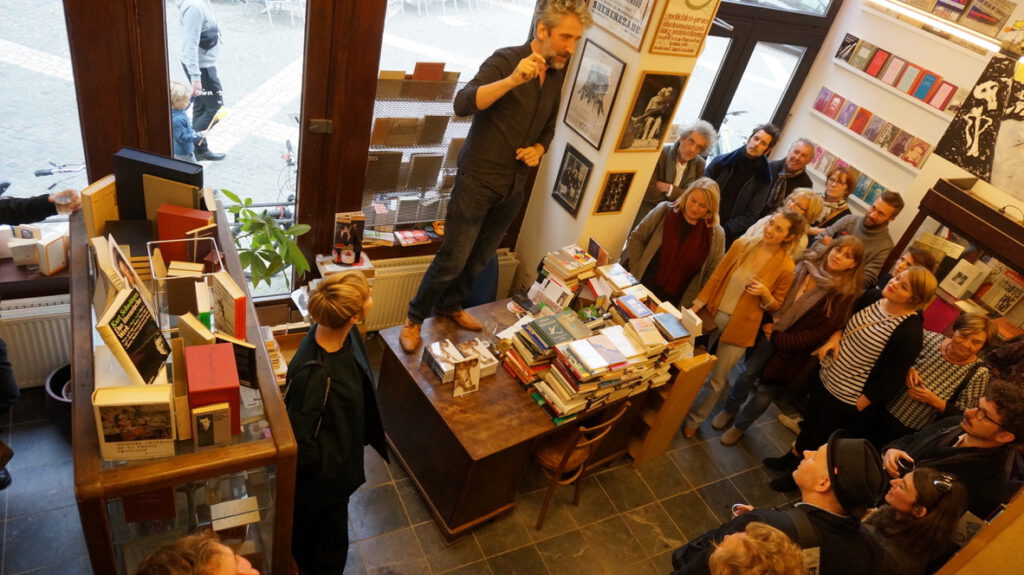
[377,300,556,540]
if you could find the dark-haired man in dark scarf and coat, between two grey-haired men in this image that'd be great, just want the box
[705,124,778,244]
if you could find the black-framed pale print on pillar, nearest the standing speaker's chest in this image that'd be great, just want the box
[563,39,626,149]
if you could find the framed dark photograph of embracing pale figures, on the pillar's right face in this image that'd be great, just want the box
[615,72,686,151]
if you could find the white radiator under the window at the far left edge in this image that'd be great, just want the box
[0,295,71,388]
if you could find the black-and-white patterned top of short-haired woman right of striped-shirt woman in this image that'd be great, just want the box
[887,331,990,430]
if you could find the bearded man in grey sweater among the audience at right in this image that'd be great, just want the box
[808,191,904,290]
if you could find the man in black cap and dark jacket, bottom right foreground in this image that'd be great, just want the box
[672,431,886,575]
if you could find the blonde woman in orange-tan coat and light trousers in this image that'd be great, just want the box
[683,208,807,438]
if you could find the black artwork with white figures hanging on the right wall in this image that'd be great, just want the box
[935,55,1024,183]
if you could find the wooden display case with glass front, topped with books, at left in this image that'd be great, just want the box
[70,203,296,574]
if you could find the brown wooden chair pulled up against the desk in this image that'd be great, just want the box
[534,401,630,531]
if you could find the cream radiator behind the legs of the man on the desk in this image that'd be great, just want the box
[366,249,519,331]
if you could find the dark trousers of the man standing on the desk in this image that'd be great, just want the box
[409,172,523,323]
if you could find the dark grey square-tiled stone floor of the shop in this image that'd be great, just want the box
[0,338,795,575]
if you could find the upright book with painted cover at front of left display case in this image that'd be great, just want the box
[92,384,174,461]
